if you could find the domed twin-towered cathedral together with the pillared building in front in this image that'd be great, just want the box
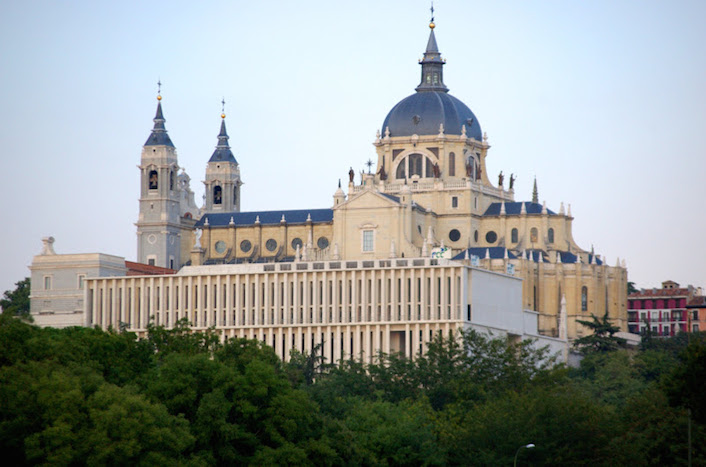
[30,21,627,361]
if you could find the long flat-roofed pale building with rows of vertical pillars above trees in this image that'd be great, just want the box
[86,258,556,362]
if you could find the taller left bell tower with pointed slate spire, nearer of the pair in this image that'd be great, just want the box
[136,87,182,269]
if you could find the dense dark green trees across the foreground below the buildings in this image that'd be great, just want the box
[0,315,706,466]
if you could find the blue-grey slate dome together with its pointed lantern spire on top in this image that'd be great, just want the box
[381,22,483,141]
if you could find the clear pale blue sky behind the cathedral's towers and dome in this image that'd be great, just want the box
[0,0,706,292]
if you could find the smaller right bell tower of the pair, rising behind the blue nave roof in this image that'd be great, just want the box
[203,101,243,213]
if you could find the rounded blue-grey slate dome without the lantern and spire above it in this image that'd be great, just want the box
[381,90,482,141]
